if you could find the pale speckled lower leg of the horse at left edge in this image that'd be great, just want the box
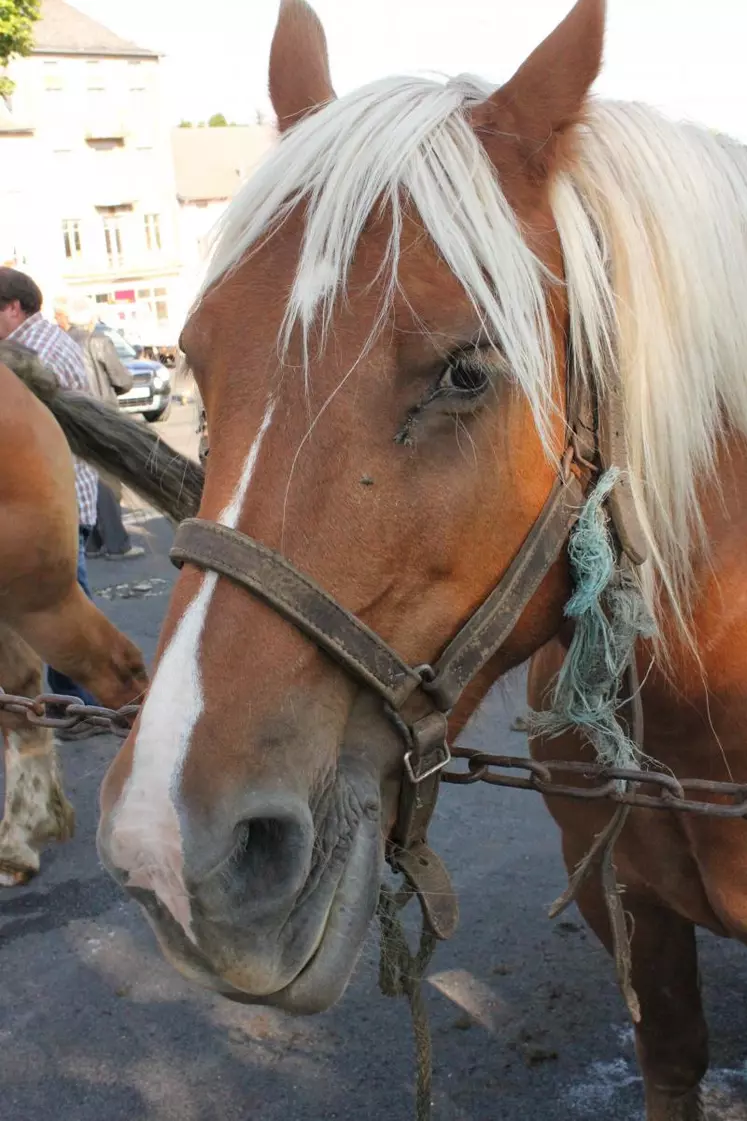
[0,626,75,887]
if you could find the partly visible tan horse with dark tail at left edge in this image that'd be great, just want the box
[0,344,200,887]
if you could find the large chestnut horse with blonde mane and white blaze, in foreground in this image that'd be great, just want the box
[99,0,747,1121]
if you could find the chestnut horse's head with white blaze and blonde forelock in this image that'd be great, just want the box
[99,0,605,1011]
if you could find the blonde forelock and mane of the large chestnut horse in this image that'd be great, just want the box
[203,77,747,626]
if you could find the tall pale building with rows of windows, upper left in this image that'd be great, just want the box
[0,0,186,345]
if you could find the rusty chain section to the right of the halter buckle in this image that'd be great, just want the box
[441,748,747,817]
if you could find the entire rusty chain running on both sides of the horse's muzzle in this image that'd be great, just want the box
[5,688,747,817]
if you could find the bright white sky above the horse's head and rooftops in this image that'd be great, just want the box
[73,0,747,141]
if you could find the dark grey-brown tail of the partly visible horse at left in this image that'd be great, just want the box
[0,342,204,521]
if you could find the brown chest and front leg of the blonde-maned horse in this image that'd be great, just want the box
[528,441,747,1121]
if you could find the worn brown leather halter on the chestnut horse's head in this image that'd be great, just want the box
[170,363,646,938]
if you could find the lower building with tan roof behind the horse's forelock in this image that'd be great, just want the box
[172,124,276,293]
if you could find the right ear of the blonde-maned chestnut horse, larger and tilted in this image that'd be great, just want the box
[472,0,607,180]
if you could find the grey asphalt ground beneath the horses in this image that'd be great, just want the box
[0,407,747,1121]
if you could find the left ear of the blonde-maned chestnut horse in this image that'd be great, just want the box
[269,0,335,132]
